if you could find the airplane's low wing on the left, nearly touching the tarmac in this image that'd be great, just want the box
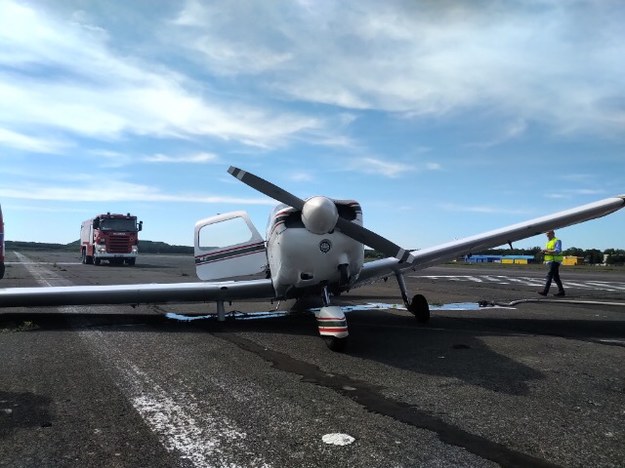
[0,279,275,307]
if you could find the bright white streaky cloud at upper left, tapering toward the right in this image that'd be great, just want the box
[0,2,324,147]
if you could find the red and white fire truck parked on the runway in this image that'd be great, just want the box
[80,213,143,265]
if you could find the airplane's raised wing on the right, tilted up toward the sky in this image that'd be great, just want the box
[353,195,625,287]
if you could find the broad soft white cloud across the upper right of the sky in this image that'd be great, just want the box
[169,0,625,138]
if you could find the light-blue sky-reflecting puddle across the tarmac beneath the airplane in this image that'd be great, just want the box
[165,302,514,322]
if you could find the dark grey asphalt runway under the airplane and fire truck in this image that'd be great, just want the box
[0,251,625,467]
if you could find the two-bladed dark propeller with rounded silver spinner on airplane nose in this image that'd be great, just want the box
[228,166,410,262]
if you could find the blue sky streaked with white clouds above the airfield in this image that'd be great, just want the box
[0,0,625,249]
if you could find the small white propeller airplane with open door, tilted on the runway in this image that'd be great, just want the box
[0,166,625,351]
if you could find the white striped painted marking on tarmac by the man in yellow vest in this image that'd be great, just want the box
[410,275,625,292]
